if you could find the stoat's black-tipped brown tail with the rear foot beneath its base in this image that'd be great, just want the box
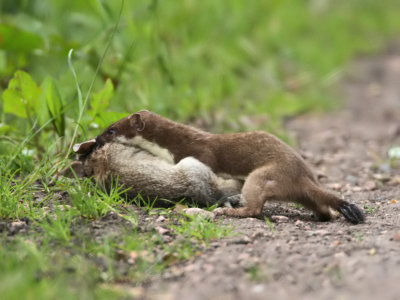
[307,180,365,224]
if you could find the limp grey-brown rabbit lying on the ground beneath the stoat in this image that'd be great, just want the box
[64,143,242,205]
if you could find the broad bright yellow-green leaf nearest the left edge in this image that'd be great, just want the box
[2,71,41,119]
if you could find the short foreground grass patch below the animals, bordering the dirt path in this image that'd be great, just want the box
[0,159,232,299]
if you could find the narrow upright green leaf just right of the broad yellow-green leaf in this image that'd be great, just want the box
[42,77,65,136]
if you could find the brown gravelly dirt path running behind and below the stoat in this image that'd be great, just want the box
[144,46,400,299]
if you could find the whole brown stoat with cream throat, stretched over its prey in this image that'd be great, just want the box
[96,111,365,224]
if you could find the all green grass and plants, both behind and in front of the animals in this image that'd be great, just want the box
[0,0,400,299]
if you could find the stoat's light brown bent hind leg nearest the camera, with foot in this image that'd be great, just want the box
[215,166,281,218]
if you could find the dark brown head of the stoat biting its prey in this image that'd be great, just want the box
[96,111,147,146]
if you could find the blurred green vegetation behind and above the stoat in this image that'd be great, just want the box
[0,0,400,165]
